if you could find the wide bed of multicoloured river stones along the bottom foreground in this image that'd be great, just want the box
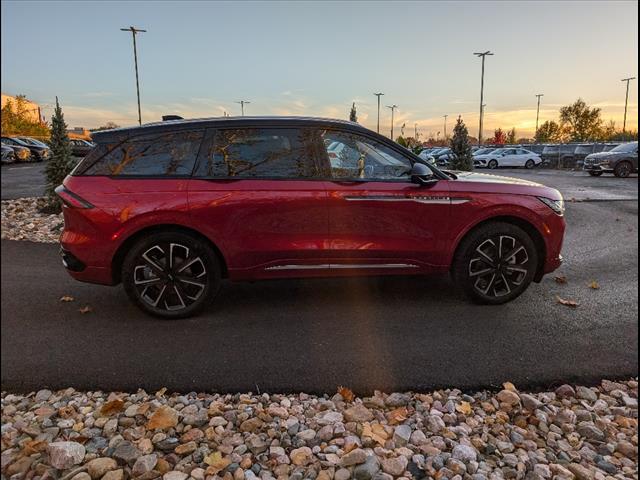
[2,379,638,480]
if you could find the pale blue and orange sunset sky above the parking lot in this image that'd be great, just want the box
[1,1,638,136]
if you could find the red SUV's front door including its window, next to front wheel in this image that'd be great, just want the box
[321,130,451,274]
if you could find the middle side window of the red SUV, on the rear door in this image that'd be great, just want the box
[197,128,326,178]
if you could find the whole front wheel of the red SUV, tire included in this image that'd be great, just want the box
[452,222,538,305]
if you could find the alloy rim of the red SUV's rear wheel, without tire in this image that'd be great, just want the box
[133,243,208,311]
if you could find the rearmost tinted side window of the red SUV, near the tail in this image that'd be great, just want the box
[74,130,204,177]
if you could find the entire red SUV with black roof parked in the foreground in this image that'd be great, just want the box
[58,117,565,318]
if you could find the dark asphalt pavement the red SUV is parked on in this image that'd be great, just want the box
[1,199,638,394]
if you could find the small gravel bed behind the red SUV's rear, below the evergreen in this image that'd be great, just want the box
[2,197,64,243]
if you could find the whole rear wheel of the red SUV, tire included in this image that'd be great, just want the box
[122,231,221,320]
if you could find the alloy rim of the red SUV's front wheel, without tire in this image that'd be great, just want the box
[468,235,529,297]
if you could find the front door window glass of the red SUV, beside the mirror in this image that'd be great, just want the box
[321,130,412,180]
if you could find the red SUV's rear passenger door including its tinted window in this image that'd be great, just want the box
[188,127,328,279]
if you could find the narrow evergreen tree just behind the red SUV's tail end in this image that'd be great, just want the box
[44,97,74,213]
